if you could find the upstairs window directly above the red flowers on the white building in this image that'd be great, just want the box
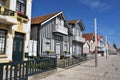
[16,0,26,14]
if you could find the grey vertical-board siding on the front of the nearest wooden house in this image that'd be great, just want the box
[39,19,70,55]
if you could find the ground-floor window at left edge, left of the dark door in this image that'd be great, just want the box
[0,29,7,54]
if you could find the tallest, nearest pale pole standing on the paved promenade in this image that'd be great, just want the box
[94,18,98,67]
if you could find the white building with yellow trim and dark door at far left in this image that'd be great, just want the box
[0,0,32,62]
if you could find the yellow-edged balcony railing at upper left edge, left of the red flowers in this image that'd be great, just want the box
[0,6,17,16]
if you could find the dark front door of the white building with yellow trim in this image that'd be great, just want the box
[12,32,24,61]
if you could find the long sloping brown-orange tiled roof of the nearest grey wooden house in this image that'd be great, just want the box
[31,11,60,24]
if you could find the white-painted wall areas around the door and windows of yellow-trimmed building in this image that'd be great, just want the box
[6,0,32,60]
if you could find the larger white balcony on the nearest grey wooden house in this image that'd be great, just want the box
[53,24,68,35]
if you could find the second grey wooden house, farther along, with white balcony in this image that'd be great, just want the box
[68,20,85,56]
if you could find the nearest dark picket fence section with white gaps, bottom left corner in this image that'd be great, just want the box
[0,61,28,80]
